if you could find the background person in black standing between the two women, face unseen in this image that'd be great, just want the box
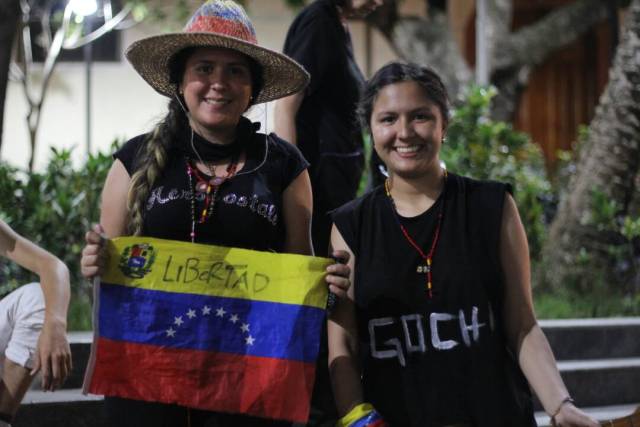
[275,0,383,255]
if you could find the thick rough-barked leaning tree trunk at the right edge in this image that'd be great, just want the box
[540,0,640,291]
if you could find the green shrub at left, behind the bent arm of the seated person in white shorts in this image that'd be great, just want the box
[0,143,117,329]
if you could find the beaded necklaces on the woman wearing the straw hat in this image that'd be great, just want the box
[187,158,238,243]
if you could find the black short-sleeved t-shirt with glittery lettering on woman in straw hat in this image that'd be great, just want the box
[114,129,308,252]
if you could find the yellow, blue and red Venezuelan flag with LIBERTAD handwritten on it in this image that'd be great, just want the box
[84,237,331,422]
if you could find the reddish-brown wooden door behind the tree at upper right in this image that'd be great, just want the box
[465,0,613,166]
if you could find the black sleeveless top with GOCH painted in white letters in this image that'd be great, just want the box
[332,173,535,427]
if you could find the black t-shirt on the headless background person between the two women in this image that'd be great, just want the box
[284,0,364,167]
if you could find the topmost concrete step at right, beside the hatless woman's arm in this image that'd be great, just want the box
[539,317,640,360]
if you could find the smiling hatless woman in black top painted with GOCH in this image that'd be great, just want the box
[328,63,598,427]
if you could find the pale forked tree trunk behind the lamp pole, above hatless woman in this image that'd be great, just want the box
[369,0,609,122]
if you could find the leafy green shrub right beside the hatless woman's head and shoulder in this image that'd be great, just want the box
[441,86,554,260]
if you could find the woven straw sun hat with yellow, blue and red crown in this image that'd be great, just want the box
[125,0,309,104]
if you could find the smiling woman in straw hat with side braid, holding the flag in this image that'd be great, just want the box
[82,0,349,426]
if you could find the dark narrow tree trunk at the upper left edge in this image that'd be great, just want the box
[0,0,20,152]
